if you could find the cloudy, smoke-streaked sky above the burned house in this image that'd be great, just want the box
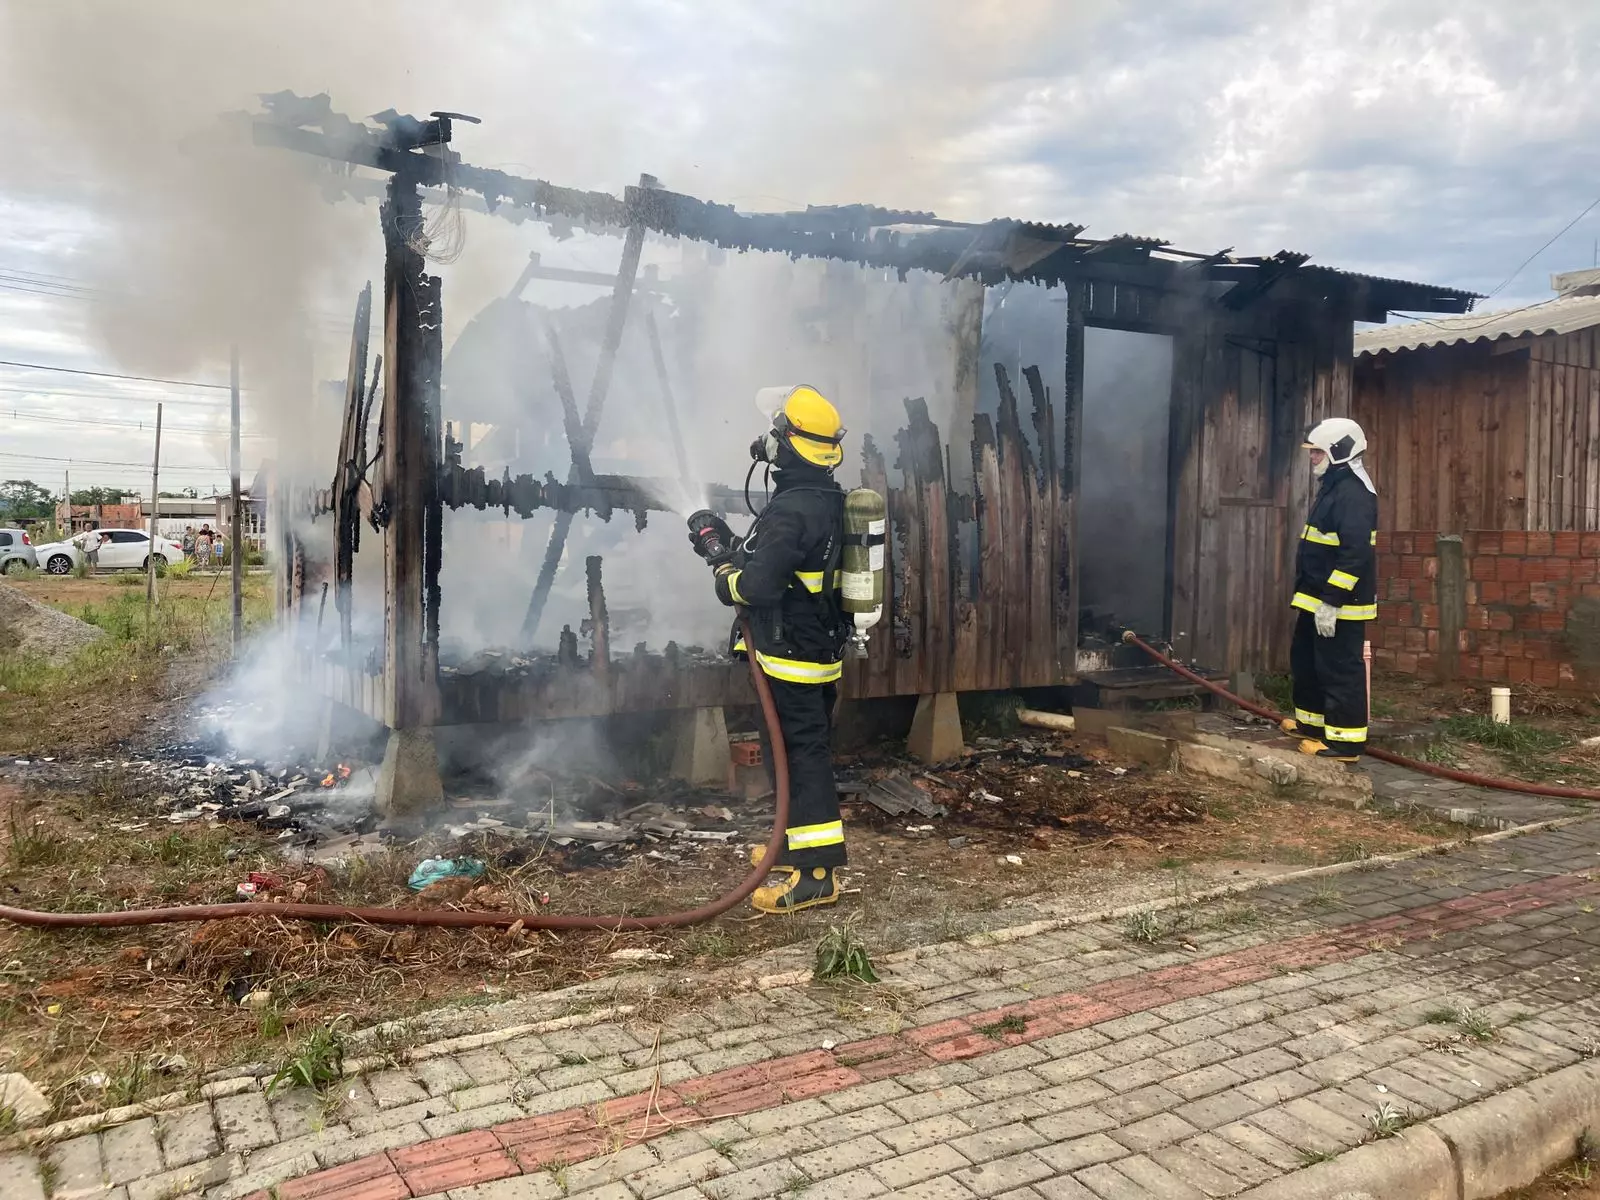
[0,0,1600,491]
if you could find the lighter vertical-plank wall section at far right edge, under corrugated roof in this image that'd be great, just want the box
[1523,328,1600,530]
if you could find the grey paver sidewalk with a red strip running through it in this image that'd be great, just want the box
[0,818,1600,1200]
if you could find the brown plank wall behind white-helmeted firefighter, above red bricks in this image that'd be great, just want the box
[1350,346,1529,533]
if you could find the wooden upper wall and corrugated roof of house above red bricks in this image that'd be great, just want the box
[1350,270,1600,533]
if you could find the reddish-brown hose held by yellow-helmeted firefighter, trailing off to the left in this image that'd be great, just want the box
[0,610,789,931]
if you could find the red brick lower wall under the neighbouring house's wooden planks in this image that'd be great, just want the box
[1371,531,1600,690]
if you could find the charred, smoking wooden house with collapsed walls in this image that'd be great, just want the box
[254,98,1474,809]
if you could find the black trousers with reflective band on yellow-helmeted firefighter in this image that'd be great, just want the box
[762,675,845,870]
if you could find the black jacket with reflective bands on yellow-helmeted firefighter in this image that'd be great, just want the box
[717,466,848,683]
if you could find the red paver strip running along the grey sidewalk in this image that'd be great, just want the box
[246,874,1600,1200]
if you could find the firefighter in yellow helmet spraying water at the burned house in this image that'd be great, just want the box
[690,386,850,912]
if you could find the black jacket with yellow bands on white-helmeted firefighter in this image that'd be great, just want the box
[1293,464,1378,621]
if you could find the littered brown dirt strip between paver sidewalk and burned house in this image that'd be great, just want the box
[0,752,1456,1114]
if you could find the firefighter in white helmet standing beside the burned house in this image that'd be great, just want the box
[1283,416,1378,762]
